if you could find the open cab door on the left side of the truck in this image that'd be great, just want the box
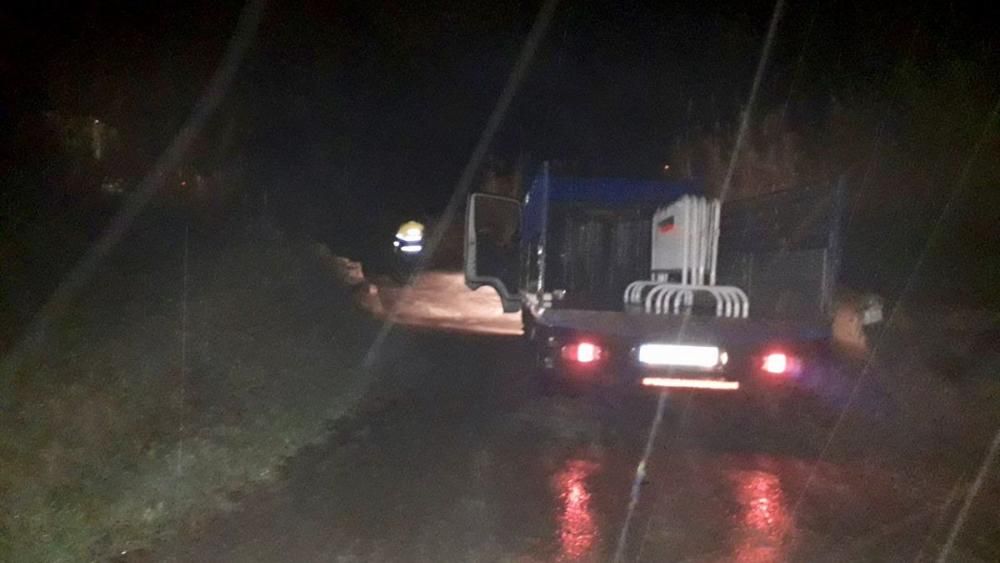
[465,194,521,313]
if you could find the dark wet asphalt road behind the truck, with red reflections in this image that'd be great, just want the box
[156,328,996,562]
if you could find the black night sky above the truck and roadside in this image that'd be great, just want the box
[0,0,997,238]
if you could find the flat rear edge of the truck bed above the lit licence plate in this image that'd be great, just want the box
[536,309,830,347]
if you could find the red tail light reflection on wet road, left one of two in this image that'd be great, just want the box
[555,459,598,561]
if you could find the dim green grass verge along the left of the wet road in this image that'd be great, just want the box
[0,215,372,562]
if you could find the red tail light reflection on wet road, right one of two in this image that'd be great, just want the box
[729,471,793,563]
